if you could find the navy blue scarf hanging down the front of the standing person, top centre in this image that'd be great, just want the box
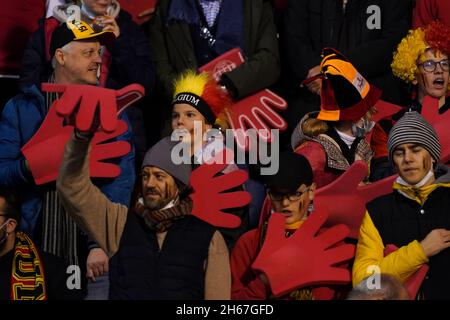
[166,0,245,55]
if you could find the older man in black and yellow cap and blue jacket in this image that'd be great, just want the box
[0,22,135,298]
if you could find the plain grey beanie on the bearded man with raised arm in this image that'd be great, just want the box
[141,137,191,185]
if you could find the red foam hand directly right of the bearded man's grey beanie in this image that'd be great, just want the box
[190,150,251,228]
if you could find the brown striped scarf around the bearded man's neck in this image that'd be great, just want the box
[133,197,192,232]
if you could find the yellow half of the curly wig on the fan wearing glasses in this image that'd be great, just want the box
[391,28,427,82]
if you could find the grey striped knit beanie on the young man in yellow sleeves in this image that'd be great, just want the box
[388,111,441,162]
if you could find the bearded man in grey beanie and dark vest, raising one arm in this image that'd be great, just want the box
[57,135,231,300]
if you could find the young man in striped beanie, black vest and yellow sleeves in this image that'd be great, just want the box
[353,112,450,299]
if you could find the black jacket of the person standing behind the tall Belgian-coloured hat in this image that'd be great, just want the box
[284,0,412,103]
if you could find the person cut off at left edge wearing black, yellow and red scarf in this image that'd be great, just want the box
[0,189,78,300]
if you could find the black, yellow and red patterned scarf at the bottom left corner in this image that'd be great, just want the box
[11,232,47,300]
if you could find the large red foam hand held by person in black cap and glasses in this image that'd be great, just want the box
[252,211,355,297]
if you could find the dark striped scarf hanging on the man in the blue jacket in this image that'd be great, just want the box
[41,75,79,265]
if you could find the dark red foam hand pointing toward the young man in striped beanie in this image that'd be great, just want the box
[314,161,396,239]
